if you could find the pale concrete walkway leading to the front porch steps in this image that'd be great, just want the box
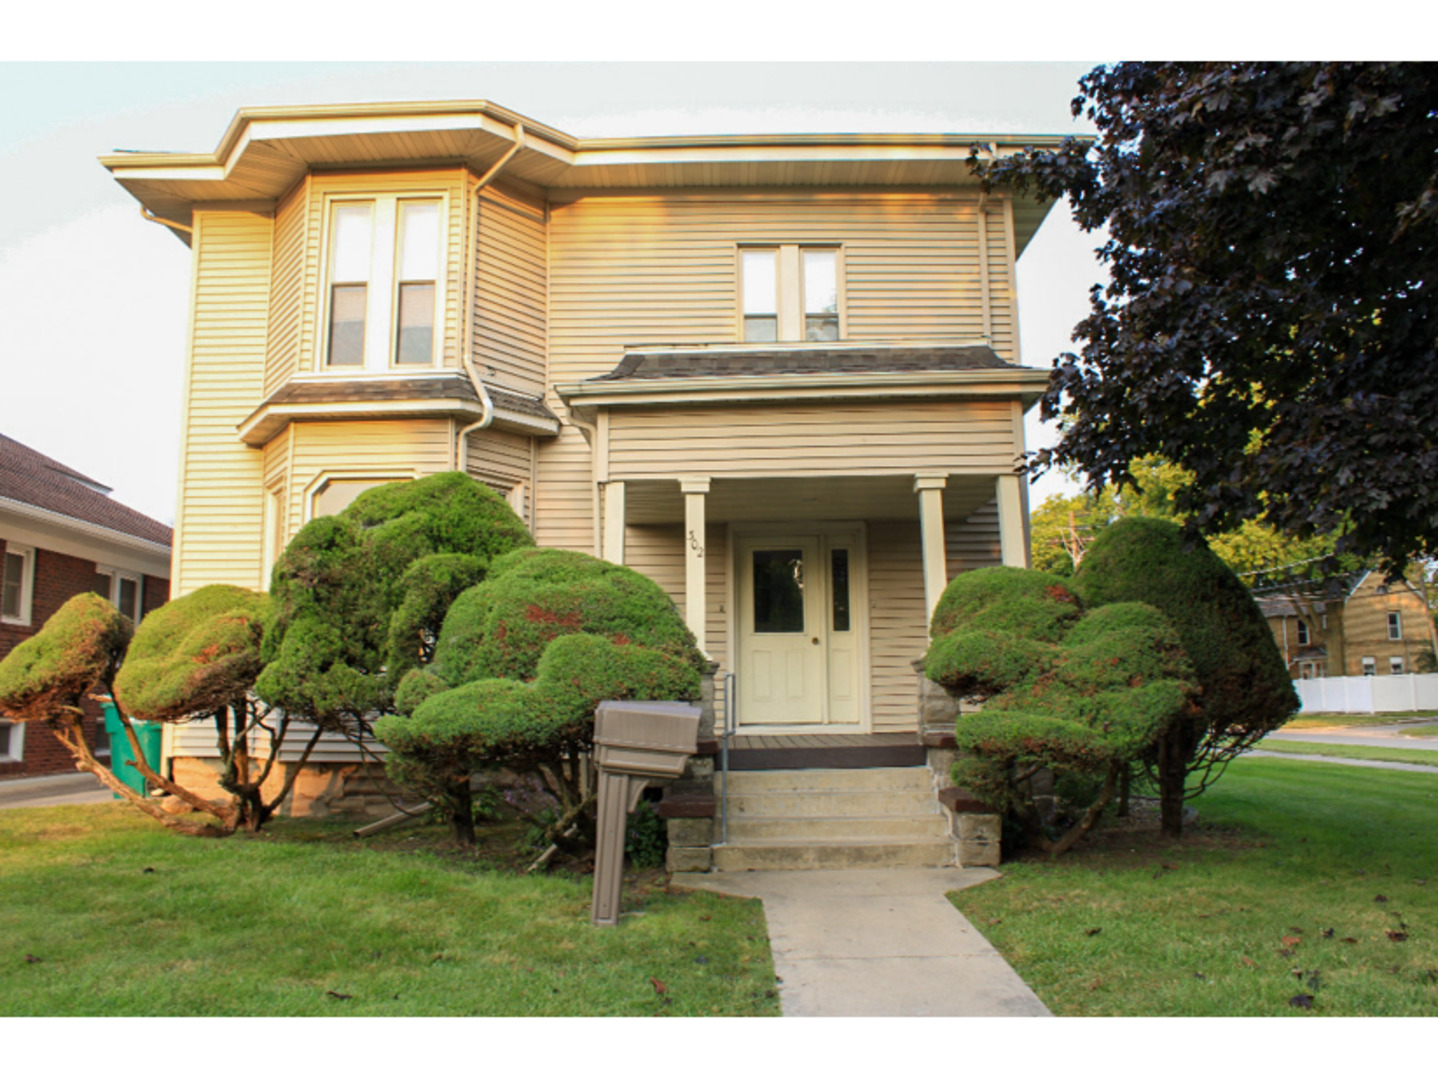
[672,869,1051,1017]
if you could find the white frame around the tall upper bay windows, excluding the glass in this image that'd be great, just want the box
[313,188,450,378]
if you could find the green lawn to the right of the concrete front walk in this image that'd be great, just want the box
[952,758,1438,1017]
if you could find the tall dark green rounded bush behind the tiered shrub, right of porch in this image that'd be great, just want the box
[1073,518,1299,837]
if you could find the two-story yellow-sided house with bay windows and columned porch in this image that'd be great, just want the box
[102,102,1058,862]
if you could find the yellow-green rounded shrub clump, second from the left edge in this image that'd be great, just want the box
[115,585,270,720]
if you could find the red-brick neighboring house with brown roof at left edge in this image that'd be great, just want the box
[0,434,170,779]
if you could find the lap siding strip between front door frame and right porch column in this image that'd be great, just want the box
[869,522,929,732]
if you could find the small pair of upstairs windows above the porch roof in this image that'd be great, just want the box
[739,244,840,341]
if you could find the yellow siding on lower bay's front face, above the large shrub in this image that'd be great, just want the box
[286,420,452,538]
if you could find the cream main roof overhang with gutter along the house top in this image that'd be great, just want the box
[101,101,1081,252]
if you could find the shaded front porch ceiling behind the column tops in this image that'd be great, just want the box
[624,475,994,525]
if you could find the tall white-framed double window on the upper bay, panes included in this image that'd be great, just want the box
[319,196,446,372]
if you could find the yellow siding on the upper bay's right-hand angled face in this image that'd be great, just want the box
[470,187,548,395]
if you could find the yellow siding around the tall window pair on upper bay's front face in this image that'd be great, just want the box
[299,167,466,371]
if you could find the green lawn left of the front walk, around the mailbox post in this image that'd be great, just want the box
[0,805,778,1017]
